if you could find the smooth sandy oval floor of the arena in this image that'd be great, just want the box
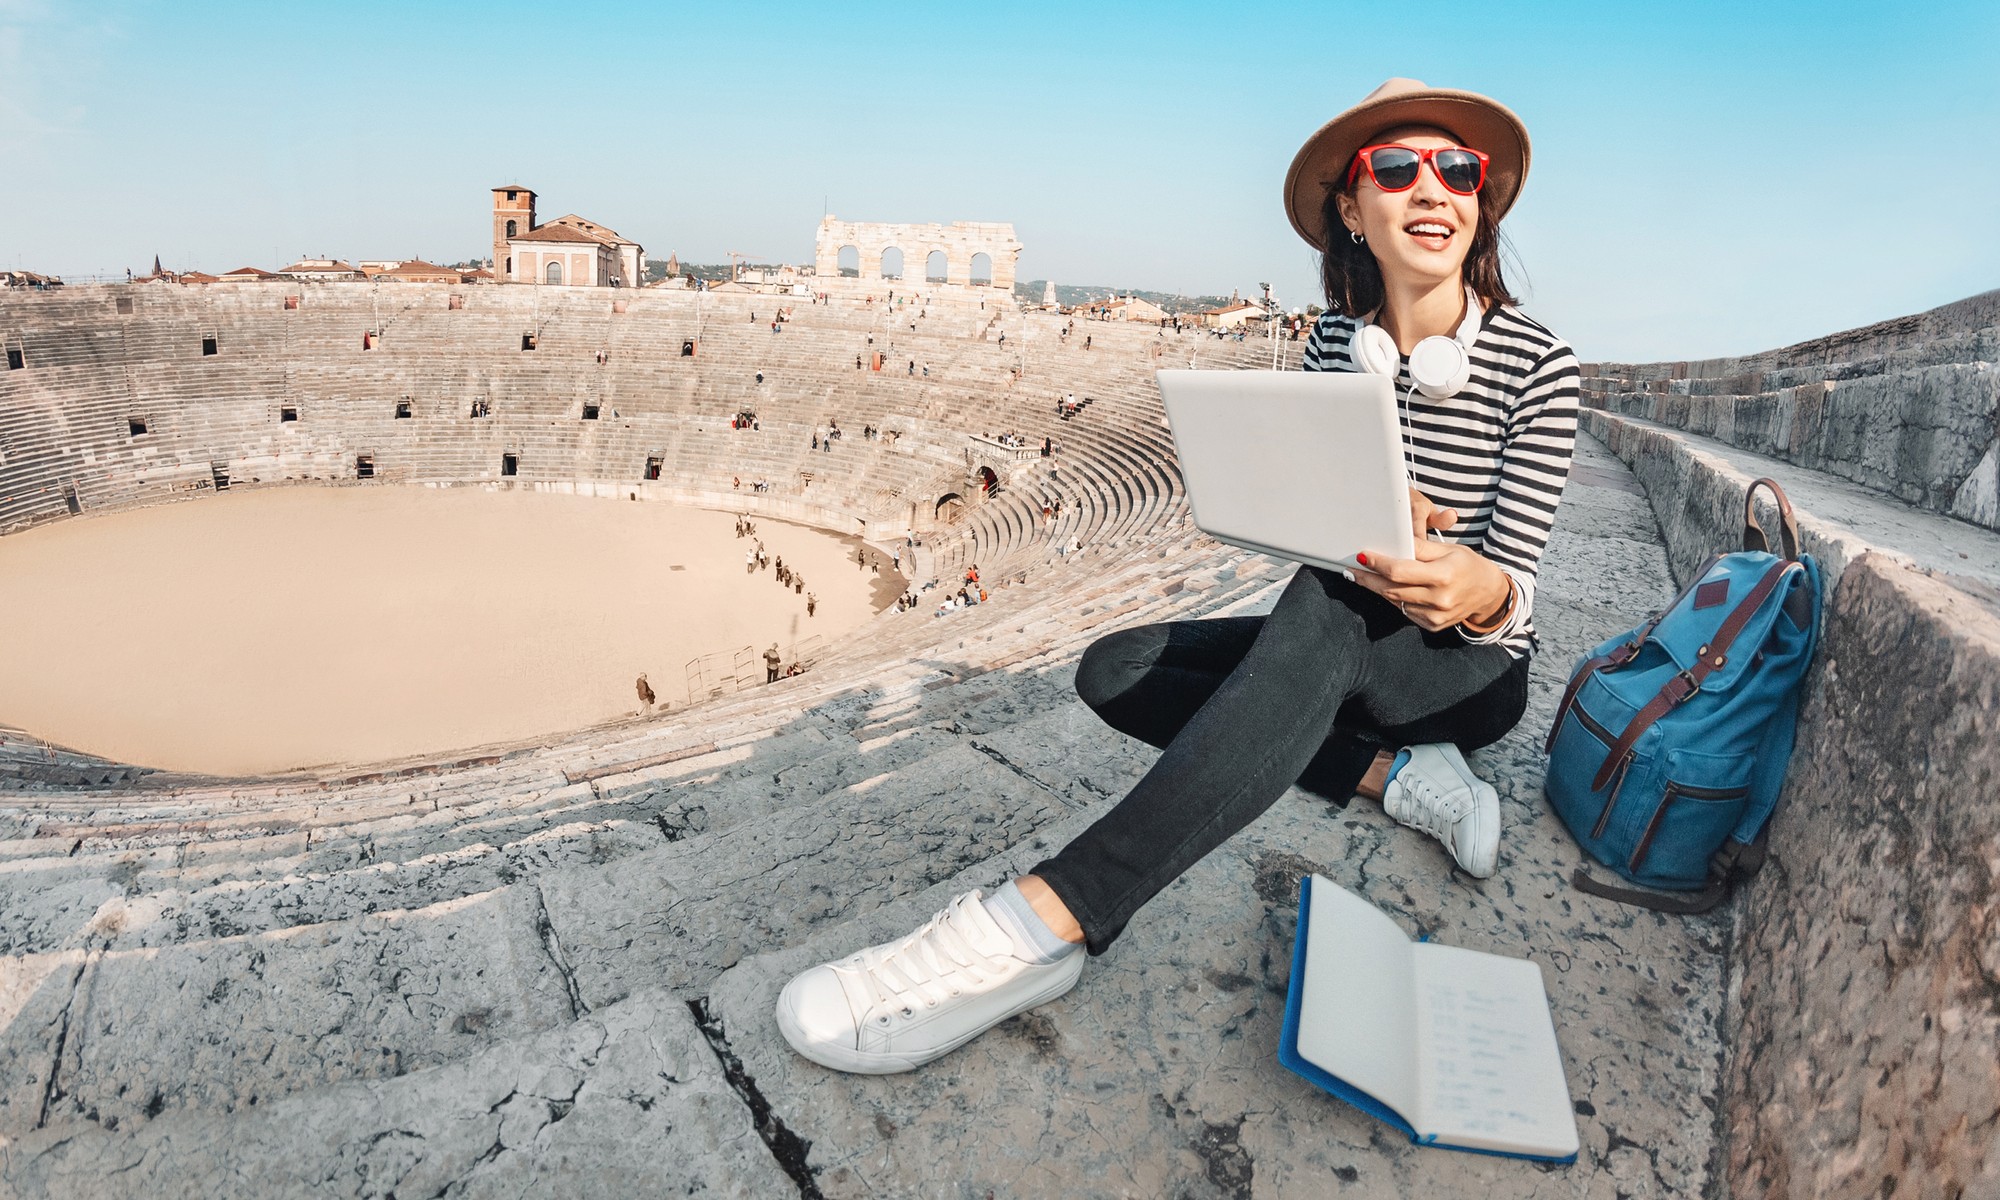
[0,486,902,774]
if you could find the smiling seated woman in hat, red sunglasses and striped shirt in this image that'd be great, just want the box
[778,80,1578,1074]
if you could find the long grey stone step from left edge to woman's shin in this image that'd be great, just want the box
[0,746,1096,1132]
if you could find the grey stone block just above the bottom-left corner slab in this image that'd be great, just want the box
[0,888,574,1132]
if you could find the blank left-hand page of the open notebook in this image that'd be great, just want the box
[1298,876,1418,1124]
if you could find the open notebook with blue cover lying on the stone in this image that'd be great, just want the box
[1278,876,1576,1162]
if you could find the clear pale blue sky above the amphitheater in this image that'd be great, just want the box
[0,0,2000,360]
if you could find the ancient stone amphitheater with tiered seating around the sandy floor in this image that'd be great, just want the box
[0,274,2000,1200]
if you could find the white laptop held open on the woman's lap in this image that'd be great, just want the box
[1160,370,1416,570]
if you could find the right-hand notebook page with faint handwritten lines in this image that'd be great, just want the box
[1410,942,1576,1158]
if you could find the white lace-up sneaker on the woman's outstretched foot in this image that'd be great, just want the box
[778,890,1086,1074]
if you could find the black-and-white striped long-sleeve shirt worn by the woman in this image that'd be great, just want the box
[1304,304,1580,658]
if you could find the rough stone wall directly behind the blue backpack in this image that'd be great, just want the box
[1584,412,2000,1200]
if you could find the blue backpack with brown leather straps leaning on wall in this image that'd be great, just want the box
[1544,480,1820,912]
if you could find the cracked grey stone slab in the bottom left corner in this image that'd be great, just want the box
[0,992,798,1200]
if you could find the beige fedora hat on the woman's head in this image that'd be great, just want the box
[1284,78,1528,250]
